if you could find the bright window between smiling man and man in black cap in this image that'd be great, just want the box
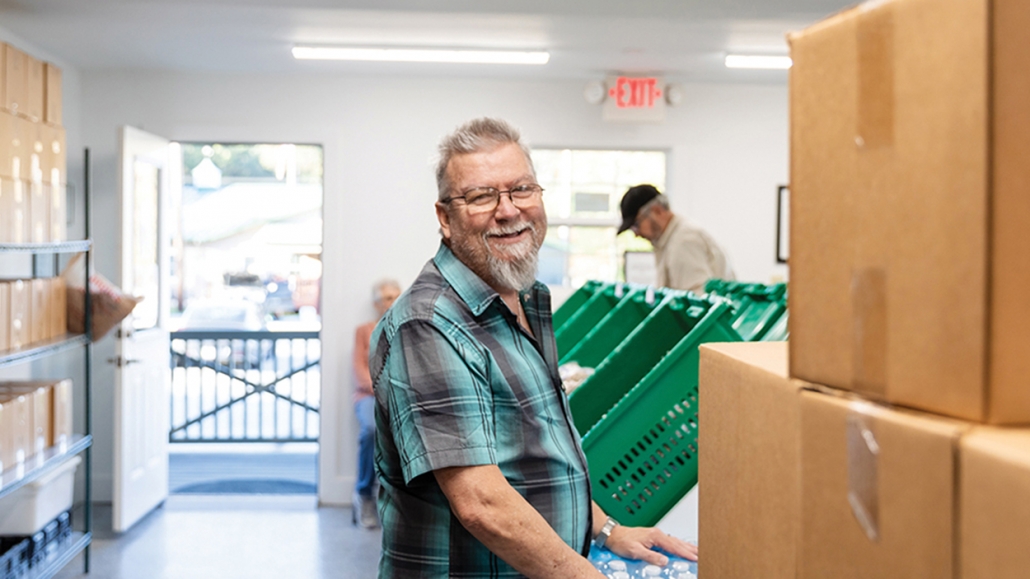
[533,148,665,287]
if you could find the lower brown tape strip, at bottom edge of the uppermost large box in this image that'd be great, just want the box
[851,268,887,397]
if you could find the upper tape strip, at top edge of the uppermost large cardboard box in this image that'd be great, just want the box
[855,0,894,149]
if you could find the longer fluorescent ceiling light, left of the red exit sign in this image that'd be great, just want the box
[294,46,551,64]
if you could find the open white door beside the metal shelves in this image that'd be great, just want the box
[113,127,178,533]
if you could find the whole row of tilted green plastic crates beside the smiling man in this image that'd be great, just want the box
[554,280,787,525]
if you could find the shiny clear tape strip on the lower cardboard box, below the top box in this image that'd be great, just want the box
[846,402,880,542]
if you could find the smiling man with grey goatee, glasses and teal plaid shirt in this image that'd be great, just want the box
[371,118,696,579]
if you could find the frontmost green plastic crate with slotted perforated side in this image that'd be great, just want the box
[573,303,740,526]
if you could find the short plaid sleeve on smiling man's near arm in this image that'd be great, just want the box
[385,320,496,484]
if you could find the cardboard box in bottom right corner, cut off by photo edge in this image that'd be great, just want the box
[959,429,1030,579]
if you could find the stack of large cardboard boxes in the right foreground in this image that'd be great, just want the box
[699,0,1030,578]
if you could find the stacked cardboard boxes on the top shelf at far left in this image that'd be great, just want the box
[0,42,67,243]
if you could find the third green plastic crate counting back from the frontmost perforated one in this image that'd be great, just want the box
[559,287,665,368]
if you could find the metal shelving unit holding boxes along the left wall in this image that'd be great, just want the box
[0,149,93,579]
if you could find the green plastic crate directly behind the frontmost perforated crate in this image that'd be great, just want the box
[569,291,716,435]
